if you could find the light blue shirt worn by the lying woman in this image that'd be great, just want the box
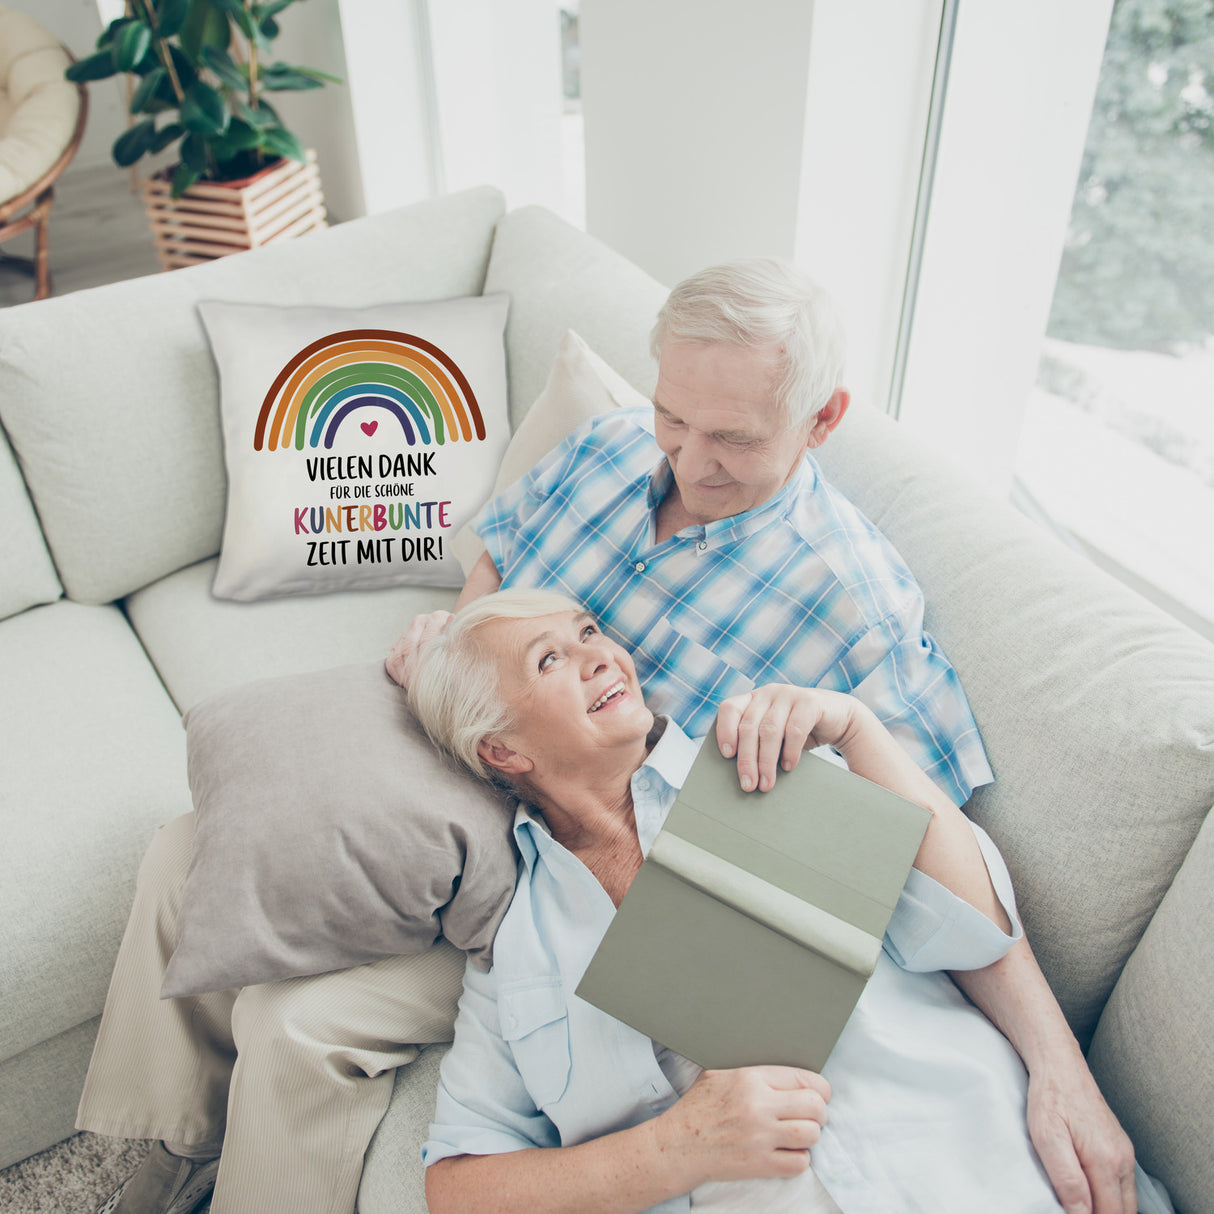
[422,722,1060,1214]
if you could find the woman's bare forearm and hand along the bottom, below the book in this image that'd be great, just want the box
[426,1066,830,1214]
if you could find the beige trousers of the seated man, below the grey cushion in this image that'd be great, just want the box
[76,815,464,1214]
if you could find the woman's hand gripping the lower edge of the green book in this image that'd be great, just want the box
[654,1066,830,1187]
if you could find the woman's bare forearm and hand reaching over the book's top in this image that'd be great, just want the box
[716,683,1012,934]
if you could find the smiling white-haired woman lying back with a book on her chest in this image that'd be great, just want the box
[409,582,1082,1214]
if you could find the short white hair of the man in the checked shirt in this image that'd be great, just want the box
[649,257,846,426]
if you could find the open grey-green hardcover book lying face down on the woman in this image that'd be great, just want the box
[577,736,931,1071]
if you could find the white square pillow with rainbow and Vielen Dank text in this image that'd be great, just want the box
[198,295,510,601]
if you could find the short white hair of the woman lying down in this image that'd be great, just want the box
[409,590,583,779]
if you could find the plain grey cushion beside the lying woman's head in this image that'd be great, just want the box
[161,663,517,997]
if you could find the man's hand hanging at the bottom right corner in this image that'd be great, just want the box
[1028,1065,1138,1214]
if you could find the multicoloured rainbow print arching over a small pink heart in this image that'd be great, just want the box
[253,329,484,452]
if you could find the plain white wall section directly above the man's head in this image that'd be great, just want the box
[582,0,815,283]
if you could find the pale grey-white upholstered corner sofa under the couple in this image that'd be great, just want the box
[0,182,1214,1214]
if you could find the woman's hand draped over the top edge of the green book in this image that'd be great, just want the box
[716,683,868,793]
